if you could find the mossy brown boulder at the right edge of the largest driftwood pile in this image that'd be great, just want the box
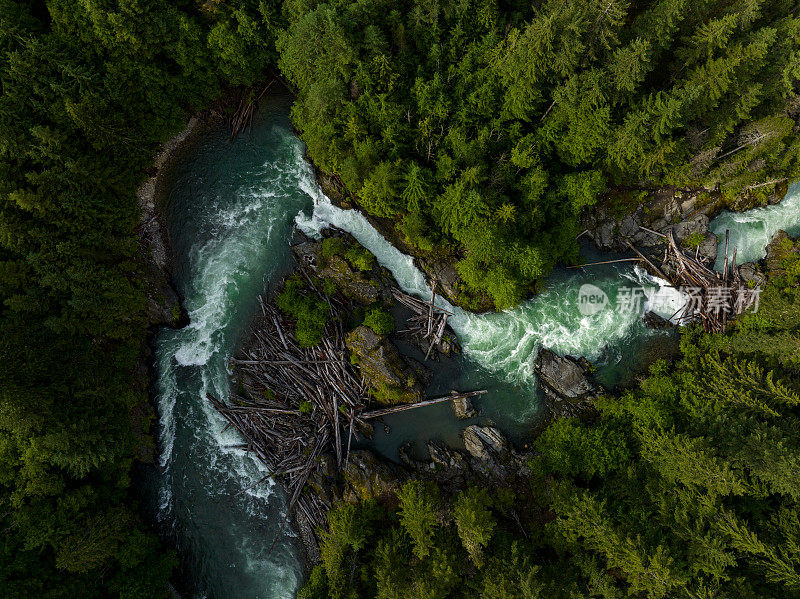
[345,325,426,404]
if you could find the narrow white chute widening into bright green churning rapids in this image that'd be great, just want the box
[296,167,684,388]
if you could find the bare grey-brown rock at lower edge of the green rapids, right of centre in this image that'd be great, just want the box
[534,349,602,417]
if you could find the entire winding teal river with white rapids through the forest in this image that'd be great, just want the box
[146,96,800,599]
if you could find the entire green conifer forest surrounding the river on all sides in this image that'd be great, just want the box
[0,0,800,599]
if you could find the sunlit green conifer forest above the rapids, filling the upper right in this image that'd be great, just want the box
[278,0,800,308]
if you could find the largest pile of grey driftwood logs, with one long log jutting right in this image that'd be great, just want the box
[208,265,486,548]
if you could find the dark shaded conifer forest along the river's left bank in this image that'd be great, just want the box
[0,0,277,599]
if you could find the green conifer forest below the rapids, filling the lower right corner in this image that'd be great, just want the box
[302,270,800,599]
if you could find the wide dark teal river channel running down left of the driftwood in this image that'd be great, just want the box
[150,99,310,599]
